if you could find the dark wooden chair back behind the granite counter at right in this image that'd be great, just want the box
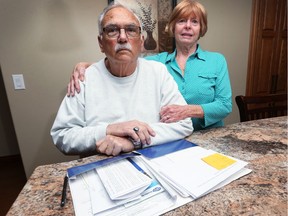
[235,94,287,122]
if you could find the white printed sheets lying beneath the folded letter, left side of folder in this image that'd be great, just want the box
[69,157,176,216]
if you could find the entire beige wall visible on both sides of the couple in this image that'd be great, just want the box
[0,0,252,177]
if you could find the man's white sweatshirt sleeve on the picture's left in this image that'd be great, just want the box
[50,80,107,155]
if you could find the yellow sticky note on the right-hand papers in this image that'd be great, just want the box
[202,153,236,170]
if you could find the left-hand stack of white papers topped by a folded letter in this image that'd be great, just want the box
[69,157,175,216]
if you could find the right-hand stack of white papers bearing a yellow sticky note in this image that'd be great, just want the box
[141,147,247,199]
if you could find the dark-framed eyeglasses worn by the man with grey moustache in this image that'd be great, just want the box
[103,25,141,38]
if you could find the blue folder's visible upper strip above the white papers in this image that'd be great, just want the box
[67,139,197,178]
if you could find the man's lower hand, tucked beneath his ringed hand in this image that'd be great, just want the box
[96,135,134,156]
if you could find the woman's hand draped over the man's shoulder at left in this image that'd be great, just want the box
[67,62,91,97]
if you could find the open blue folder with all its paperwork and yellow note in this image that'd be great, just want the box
[67,140,251,216]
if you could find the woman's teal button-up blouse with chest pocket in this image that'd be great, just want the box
[146,45,232,130]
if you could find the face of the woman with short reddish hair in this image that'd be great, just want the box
[174,16,201,46]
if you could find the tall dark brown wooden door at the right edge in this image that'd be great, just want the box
[246,0,287,95]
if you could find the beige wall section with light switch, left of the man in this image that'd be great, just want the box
[0,0,107,177]
